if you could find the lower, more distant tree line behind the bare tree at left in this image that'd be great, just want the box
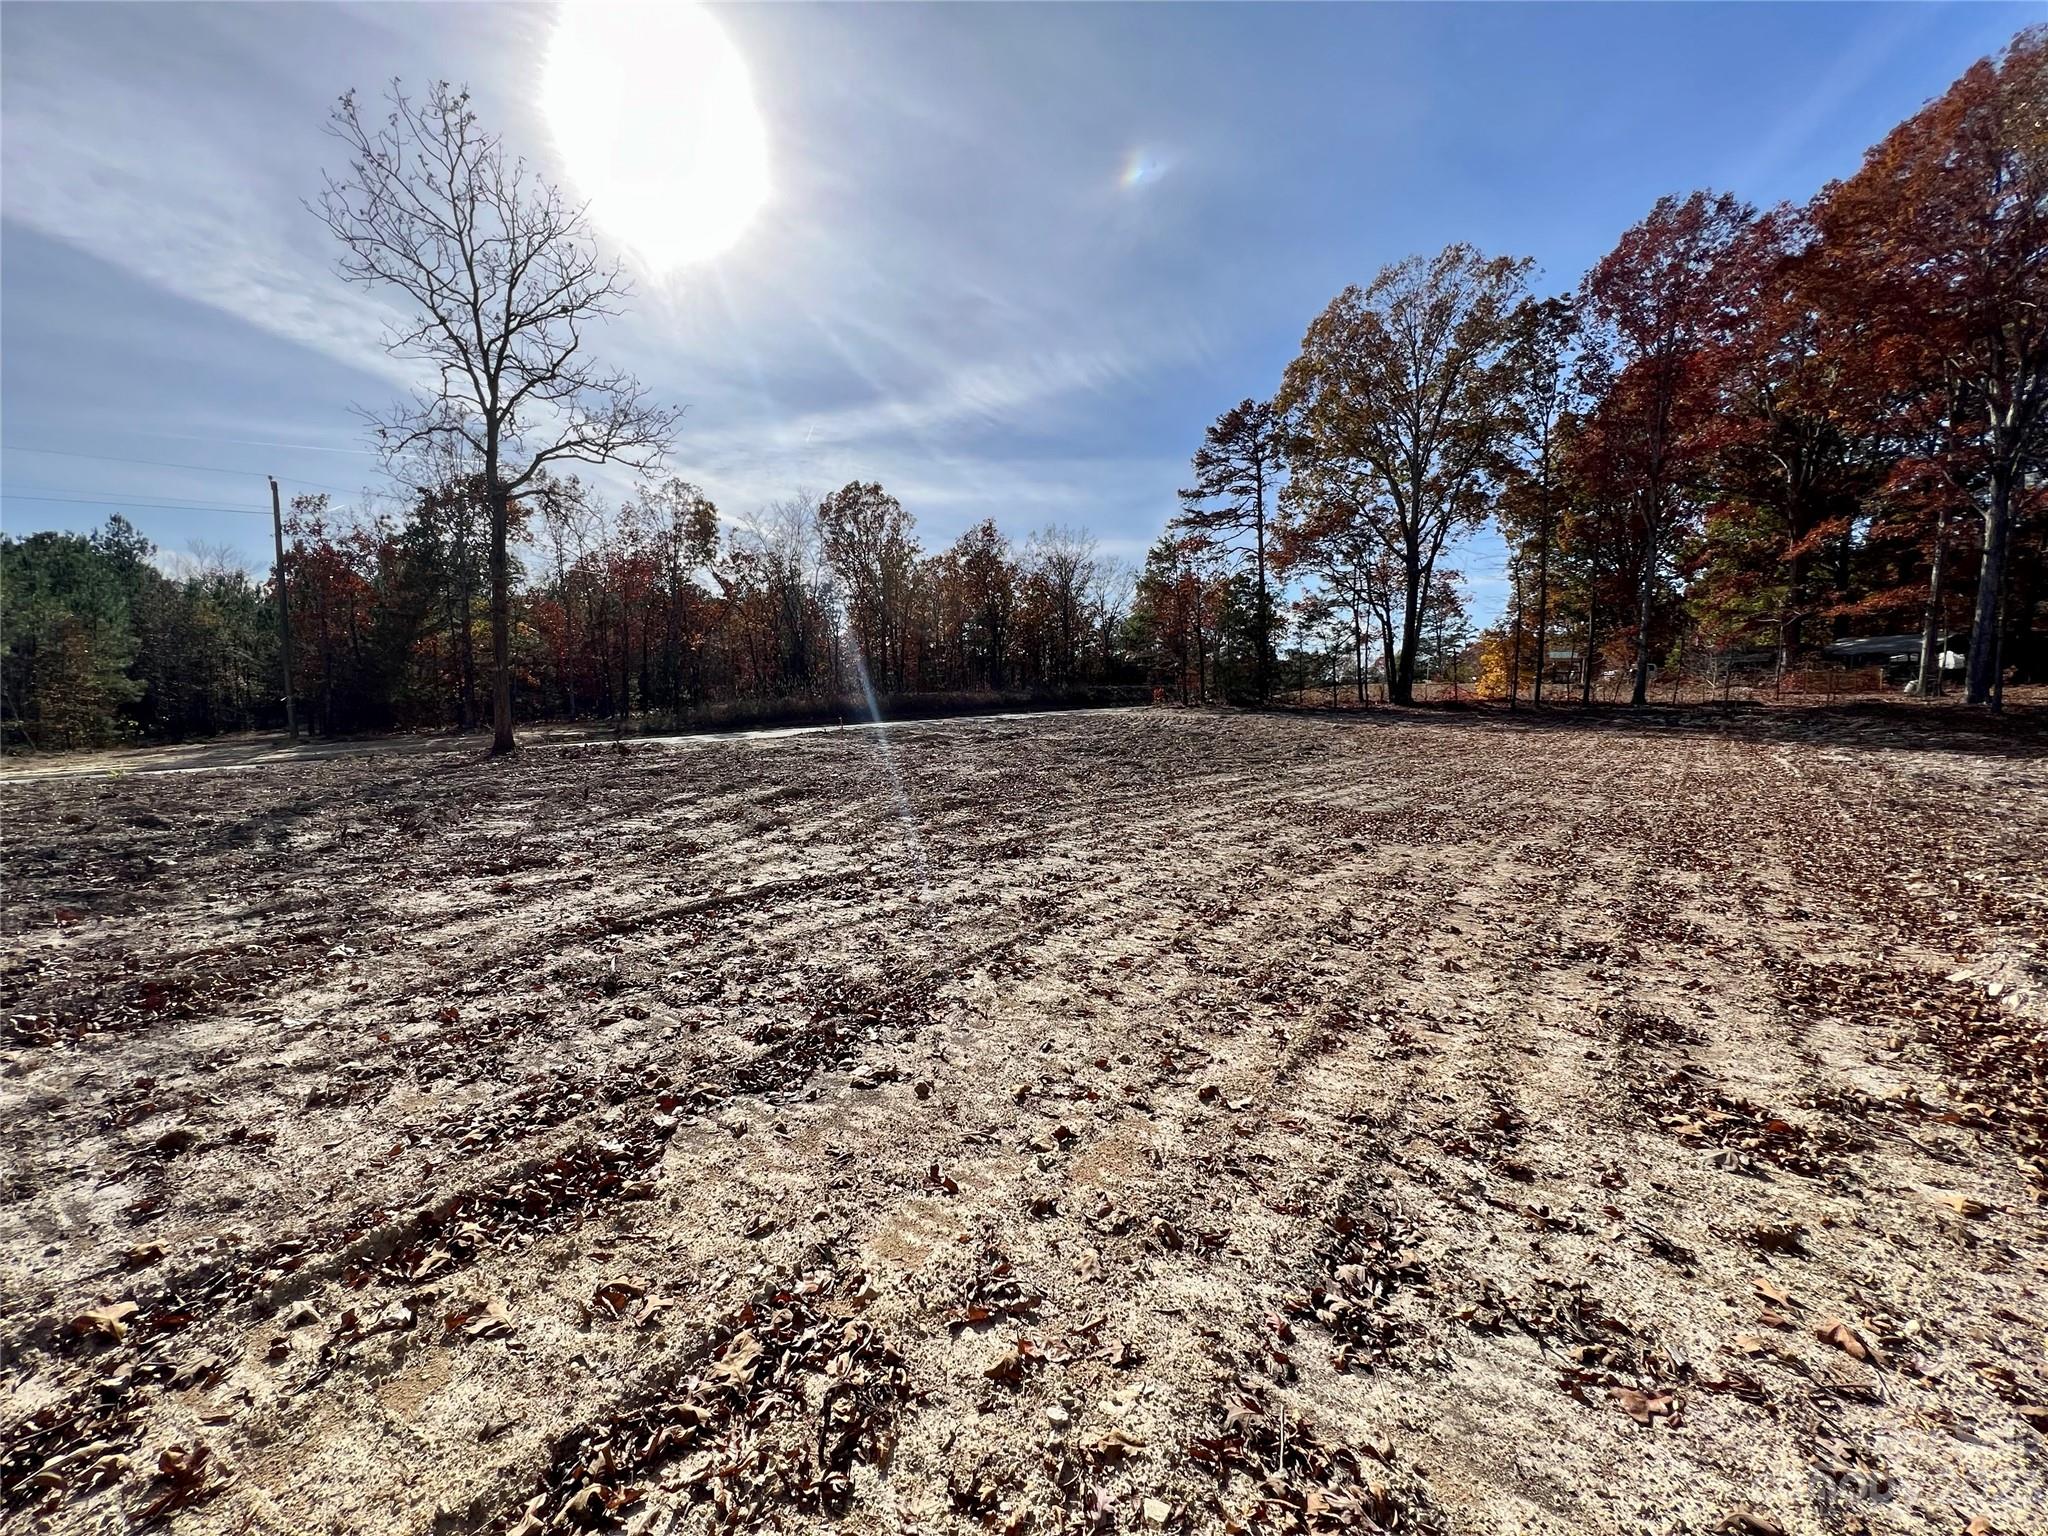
[0,487,1153,750]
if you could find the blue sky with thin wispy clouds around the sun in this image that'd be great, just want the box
[0,2,2048,614]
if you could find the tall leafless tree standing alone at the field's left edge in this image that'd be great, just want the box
[313,80,680,754]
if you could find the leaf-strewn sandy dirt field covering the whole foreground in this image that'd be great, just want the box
[0,711,2048,1536]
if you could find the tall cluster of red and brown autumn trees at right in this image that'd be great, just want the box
[1179,29,2048,705]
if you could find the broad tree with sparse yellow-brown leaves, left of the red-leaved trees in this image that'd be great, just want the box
[1276,246,1530,705]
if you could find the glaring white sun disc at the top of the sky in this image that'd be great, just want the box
[541,2,768,270]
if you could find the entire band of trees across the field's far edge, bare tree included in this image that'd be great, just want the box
[0,29,2048,748]
